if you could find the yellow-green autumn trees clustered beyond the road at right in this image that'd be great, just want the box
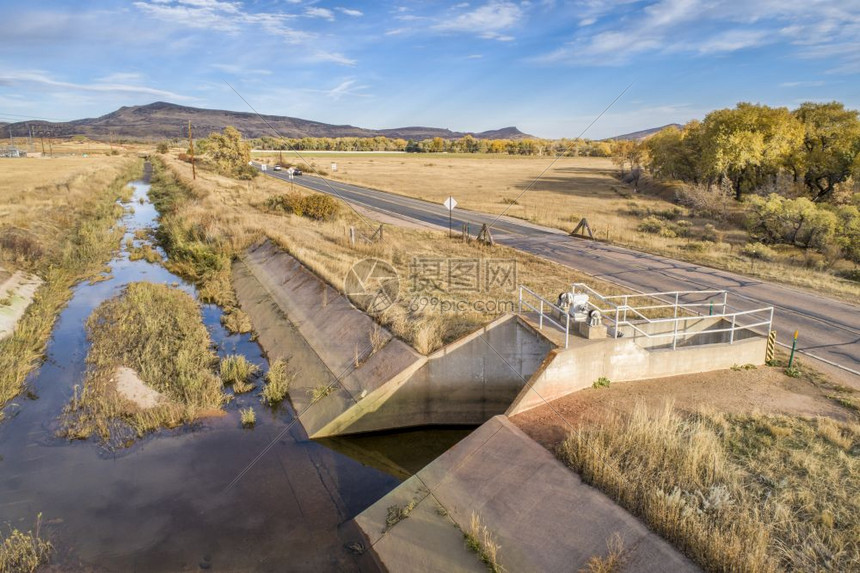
[624,102,860,263]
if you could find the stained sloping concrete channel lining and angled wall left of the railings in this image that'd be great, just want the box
[233,242,553,437]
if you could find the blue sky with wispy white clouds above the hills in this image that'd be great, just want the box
[0,0,860,138]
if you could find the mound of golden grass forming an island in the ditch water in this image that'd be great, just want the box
[61,283,225,445]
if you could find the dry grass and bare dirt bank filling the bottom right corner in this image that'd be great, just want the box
[513,367,860,571]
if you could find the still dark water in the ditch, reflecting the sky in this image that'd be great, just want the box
[0,164,468,571]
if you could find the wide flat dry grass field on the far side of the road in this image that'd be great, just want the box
[255,152,860,301]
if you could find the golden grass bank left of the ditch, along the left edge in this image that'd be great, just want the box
[0,158,142,416]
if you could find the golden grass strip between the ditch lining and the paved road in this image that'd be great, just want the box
[153,158,632,353]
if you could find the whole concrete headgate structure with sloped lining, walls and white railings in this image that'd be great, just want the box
[233,241,772,438]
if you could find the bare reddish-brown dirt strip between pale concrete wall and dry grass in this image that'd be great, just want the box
[511,366,857,449]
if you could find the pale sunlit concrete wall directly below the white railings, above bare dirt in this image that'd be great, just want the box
[507,333,767,416]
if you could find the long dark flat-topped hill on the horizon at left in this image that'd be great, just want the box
[6,102,531,141]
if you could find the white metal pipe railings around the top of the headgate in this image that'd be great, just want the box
[519,283,773,349]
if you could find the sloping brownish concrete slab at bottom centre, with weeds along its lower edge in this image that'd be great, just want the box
[355,416,698,572]
